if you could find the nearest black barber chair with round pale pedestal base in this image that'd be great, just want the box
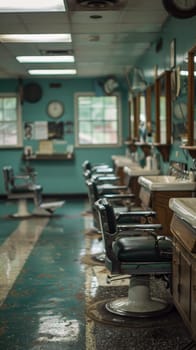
[95,198,172,317]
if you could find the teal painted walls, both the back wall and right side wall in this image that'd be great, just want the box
[0,17,196,194]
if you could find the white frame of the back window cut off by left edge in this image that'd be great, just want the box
[0,93,23,149]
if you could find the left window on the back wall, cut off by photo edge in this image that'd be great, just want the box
[0,94,22,147]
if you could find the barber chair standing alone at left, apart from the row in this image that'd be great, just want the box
[3,166,64,217]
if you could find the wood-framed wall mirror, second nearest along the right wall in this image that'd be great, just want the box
[155,71,171,145]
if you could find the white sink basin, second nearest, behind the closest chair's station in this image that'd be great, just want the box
[138,175,196,191]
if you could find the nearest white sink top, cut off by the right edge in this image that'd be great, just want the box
[169,198,196,228]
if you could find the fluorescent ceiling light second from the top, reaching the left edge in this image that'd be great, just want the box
[0,34,72,43]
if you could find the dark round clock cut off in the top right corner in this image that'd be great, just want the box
[162,0,196,18]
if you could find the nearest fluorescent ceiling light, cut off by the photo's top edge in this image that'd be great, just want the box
[0,0,65,12]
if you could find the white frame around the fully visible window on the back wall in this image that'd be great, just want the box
[74,92,122,148]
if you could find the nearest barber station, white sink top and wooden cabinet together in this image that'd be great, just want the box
[169,198,196,340]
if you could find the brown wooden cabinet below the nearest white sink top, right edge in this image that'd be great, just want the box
[171,214,196,339]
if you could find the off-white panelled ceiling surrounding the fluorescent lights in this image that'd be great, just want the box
[0,0,168,78]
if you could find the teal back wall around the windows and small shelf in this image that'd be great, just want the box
[0,78,129,194]
